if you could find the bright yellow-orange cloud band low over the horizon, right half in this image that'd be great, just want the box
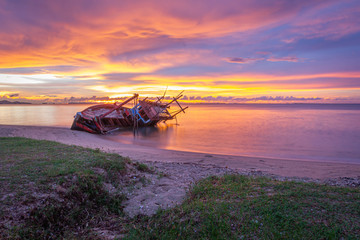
[128,72,360,96]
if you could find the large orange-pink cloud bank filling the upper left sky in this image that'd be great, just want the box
[0,1,320,72]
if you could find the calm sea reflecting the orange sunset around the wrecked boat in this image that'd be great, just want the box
[0,104,360,163]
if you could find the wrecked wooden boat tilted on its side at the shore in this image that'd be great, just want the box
[71,92,188,134]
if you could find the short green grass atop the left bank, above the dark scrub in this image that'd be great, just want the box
[0,138,129,184]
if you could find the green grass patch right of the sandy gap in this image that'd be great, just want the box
[127,175,360,239]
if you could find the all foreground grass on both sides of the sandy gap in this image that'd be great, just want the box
[0,138,360,239]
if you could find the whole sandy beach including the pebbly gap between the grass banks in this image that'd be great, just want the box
[0,125,360,216]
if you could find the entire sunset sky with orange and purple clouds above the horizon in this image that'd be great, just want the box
[0,0,360,103]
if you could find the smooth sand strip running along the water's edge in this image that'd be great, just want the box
[0,125,360,180]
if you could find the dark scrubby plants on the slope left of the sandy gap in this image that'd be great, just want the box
[17,172,125,239]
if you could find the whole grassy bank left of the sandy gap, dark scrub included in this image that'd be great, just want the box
[0,138,130,239]
